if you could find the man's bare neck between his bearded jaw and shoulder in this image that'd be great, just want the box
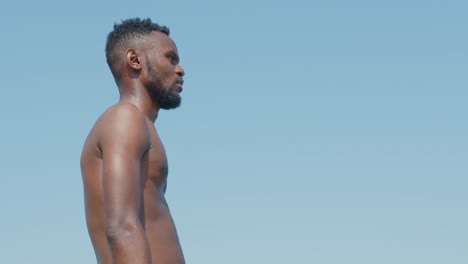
[117,81,159,123]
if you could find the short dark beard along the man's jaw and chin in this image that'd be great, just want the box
[146,63,182,110]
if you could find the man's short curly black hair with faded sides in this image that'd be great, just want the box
[106,18,169,79]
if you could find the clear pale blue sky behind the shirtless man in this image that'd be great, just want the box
[0,0,468,264]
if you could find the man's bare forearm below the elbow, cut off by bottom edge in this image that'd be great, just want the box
[107,225,151,264]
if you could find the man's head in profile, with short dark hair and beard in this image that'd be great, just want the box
[106,18,185,109]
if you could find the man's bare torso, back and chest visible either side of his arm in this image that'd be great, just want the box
[81,106,185,264]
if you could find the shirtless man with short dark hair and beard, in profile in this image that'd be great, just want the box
[81,18,185,264]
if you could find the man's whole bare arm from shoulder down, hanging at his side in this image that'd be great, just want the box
[100,105,151,264]
